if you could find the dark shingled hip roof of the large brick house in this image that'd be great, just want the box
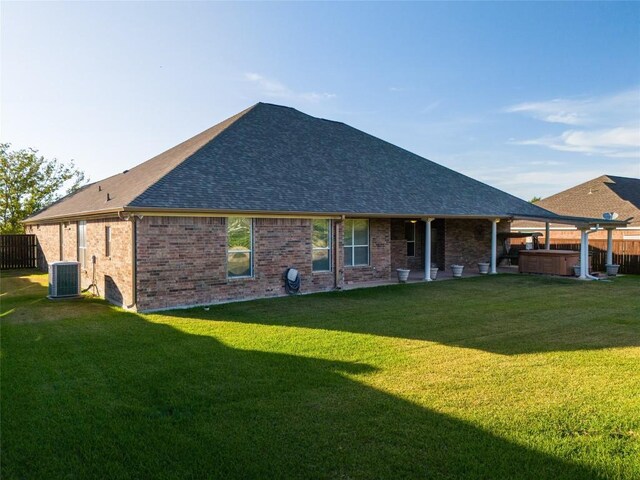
[27,103,624,223]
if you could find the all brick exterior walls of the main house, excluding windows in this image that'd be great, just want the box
[27,217,509,311]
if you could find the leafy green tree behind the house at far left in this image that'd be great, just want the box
[0,143,86,233]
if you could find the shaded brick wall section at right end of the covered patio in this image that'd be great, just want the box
[438,218,510,269]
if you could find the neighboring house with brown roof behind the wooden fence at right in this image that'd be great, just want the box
[511,175,640,243]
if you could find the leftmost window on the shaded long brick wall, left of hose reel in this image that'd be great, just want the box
[227,217,253,278]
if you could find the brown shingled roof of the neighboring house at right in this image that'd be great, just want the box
[512,175,640,229]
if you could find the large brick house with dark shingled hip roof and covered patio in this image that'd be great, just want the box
[25,103,619,311]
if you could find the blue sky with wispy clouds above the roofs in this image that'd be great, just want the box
[0,2,640,200]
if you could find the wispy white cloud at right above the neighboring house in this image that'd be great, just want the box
[505,89,640,158]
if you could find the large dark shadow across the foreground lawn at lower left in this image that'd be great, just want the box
[1,272,597,479]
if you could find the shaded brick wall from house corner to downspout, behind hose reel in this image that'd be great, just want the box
[136,217,335,310]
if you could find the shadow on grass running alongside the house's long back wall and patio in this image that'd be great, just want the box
[169,275,640,355]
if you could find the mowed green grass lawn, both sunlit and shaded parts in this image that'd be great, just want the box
[0,272,640,480]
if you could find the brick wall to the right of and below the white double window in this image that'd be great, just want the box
[341,218,391,284]
